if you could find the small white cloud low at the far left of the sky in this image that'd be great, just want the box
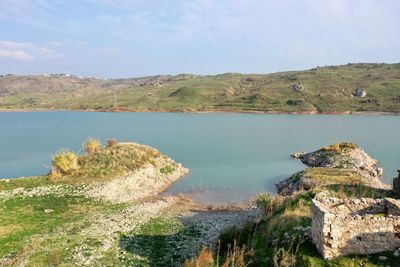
[0,41,64,60]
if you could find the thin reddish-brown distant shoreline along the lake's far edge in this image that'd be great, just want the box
[0,109,400,116]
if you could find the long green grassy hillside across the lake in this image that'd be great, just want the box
[0,63,400,113]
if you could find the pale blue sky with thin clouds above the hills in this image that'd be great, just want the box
[0,0,400,78]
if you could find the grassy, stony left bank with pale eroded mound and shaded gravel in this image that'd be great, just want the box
[0,140,259,266]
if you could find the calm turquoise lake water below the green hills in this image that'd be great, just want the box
[0,112,400,203]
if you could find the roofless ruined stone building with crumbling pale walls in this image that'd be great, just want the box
[311,195,400,259]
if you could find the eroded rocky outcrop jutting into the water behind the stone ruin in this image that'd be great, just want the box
[276,143,390,195]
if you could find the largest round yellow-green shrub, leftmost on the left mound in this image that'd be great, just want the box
[51,150,79,176]
